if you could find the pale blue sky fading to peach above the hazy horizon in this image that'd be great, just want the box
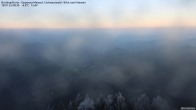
[0,0,196,28]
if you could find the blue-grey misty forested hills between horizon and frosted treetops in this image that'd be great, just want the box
[0,29,196,110]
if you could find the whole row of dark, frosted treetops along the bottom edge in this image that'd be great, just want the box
[48,93,171,110]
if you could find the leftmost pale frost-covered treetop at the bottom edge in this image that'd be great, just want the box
[78,96,94,110]
